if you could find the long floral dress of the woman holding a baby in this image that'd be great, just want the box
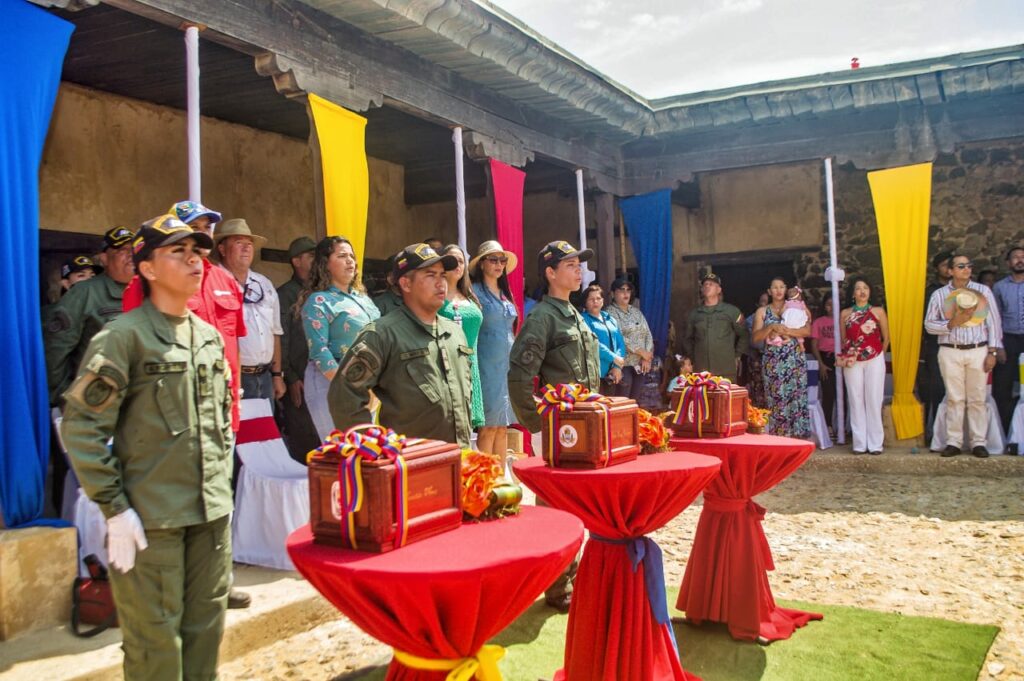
[762,305,811,437]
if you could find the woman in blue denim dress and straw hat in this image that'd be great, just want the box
[469,241,518,460]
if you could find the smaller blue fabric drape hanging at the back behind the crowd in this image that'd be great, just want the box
[618,189,672,356]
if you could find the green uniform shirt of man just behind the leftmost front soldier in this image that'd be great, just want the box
[43,274,125,405]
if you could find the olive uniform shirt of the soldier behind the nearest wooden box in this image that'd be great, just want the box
[328,306,473,448]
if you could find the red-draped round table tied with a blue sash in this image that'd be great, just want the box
[514,453,720,681]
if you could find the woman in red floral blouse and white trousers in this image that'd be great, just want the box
[836,276,889,455]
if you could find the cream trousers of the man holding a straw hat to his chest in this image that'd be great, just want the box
[939,345,988,448]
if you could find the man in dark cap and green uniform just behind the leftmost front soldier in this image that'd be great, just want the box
[43,227,135,405]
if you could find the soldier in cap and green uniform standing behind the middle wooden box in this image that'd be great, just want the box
[509,241,601,612]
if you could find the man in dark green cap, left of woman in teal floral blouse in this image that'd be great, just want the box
[278,237,319,463]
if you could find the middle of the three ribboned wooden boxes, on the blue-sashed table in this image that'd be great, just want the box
[537,383,640,468]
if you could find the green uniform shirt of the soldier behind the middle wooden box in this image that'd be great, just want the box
[509,296,601,432]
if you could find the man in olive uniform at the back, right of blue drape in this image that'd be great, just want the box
[682,272,751,382]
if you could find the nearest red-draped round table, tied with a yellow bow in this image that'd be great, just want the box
[288,506,583,681]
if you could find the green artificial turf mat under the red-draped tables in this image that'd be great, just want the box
[343,589,999,681]
